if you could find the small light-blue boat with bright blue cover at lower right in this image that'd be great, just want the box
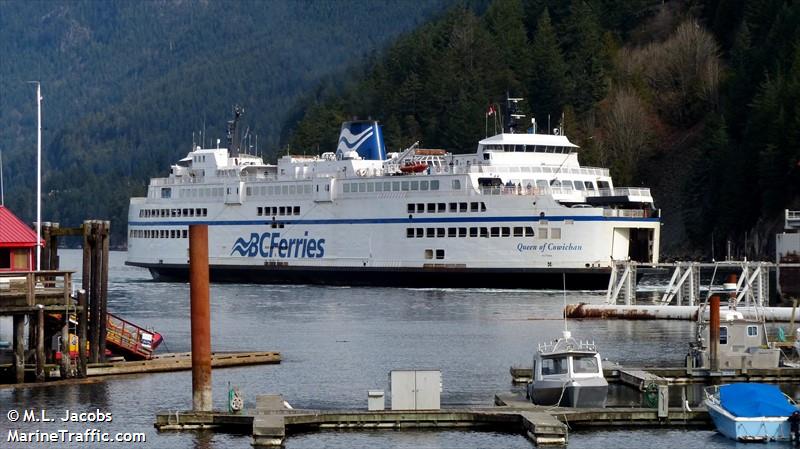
[704,383,798,442]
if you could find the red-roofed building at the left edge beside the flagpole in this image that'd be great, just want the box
[0,206,42,272]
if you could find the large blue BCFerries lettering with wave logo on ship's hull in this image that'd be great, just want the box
[231,231,325,259]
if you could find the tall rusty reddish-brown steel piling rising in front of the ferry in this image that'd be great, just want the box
[189,225,212,412]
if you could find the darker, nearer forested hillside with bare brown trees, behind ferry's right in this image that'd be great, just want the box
[291,0,800,258]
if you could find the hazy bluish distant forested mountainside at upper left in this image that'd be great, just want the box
[0,0,452,244]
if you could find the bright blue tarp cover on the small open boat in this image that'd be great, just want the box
[719,383,797,418]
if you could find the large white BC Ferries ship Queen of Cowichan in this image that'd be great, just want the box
[126,99,661,289]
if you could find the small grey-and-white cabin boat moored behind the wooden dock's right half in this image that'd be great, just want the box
[527,331,608,408]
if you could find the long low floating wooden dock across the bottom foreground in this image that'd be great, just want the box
[155,393,710,447]
